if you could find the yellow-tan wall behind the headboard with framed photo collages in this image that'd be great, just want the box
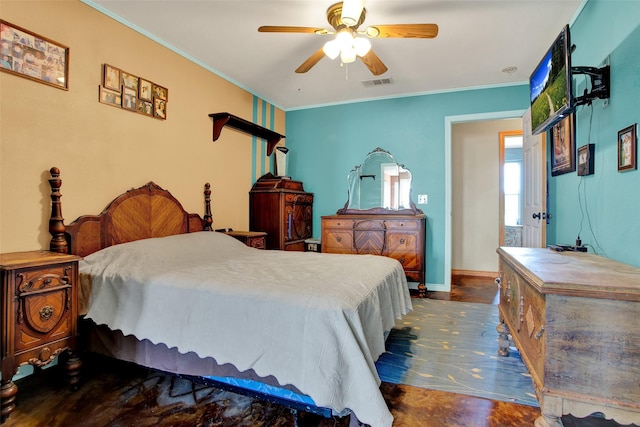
[0,0,285,252]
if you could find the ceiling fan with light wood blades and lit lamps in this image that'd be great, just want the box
[258,0,438,76]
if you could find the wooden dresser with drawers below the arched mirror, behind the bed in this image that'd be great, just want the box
[321,214,426,288]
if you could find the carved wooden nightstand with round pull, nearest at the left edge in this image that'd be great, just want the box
[0,251,82,421]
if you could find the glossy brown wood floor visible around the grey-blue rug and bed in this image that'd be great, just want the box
[3,276,632,427]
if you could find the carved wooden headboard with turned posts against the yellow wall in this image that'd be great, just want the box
[49,167,213,256]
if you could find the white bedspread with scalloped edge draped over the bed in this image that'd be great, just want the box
[80,232,411,427]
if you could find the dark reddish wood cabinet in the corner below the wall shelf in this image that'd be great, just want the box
[249,174,313,251]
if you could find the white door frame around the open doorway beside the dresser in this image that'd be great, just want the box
[442,110,526,292]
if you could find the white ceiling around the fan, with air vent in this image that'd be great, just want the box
[89,0,586,111]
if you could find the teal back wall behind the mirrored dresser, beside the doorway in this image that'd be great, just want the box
[286,85,529,284]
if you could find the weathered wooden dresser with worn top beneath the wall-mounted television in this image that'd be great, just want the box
[498,248,640,427]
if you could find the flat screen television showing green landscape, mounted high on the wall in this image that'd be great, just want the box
[529,25,574,135]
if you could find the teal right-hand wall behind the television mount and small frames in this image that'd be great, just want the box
[547,0,640,267]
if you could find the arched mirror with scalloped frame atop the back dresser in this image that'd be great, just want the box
[338,148,422,214]
